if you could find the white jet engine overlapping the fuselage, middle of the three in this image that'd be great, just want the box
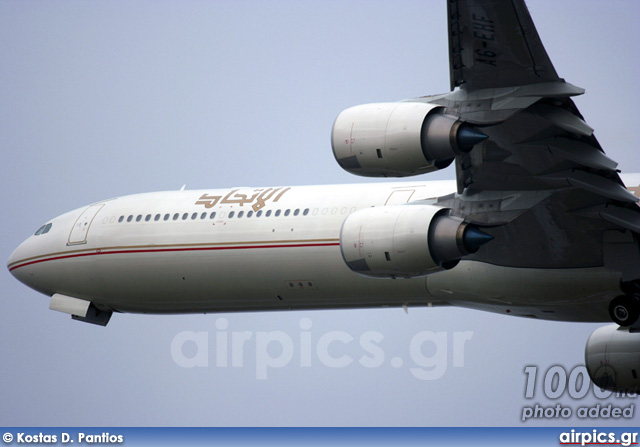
[340,205,493,278]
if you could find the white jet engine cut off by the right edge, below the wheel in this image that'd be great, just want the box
[584,324,640,392]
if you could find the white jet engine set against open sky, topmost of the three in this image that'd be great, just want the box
[331,102,487,177]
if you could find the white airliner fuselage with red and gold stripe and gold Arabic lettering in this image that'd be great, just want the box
[8,181,619,321]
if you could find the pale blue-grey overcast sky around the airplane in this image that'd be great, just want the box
[0,0,640,426]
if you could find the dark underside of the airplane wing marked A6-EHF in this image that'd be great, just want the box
[421,0,640,280]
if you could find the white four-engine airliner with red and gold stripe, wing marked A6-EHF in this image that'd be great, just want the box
[8,0,640,391]
